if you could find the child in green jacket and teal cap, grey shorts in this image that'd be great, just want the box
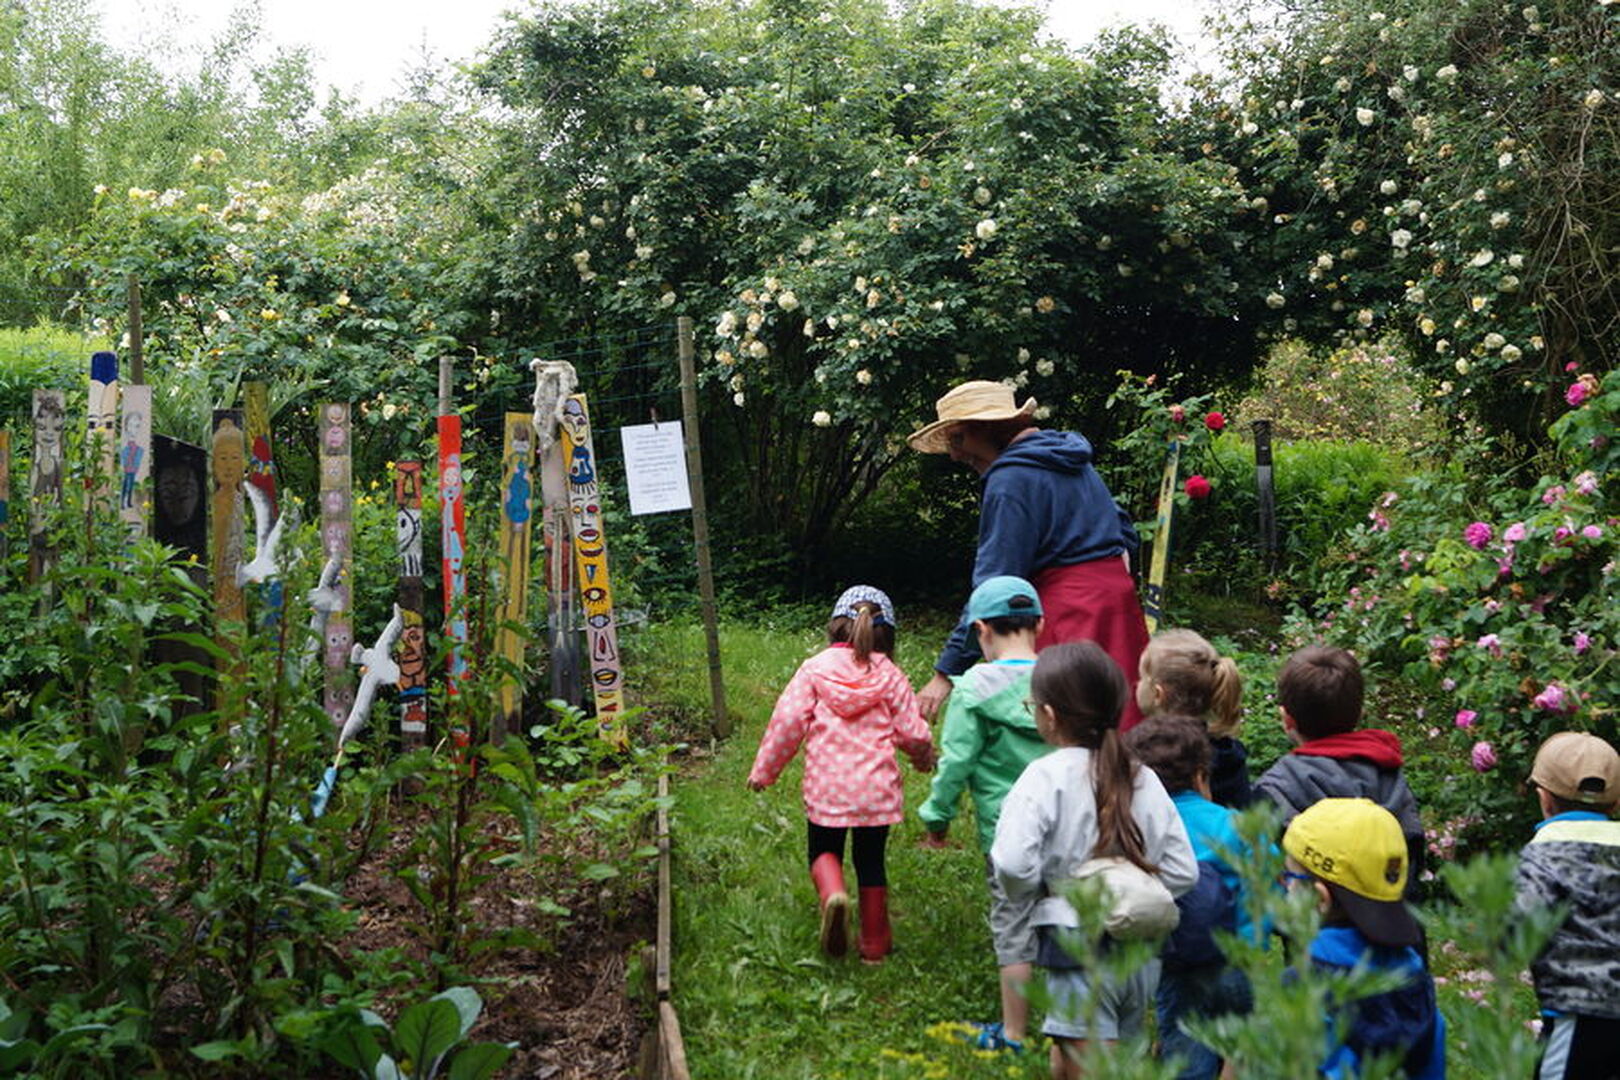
[917,575,1051,1051]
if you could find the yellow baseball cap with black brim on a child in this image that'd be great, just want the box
[1283,798,1422,946]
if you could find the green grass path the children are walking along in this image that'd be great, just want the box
[643,617,1536,1080]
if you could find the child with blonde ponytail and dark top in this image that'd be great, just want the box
[1136,630,1254,810]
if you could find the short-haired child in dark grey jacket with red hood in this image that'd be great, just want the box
[1254,644,1424,899]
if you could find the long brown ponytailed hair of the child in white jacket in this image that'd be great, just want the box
[1029,641,1158,874]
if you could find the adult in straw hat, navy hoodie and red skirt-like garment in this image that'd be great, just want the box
[907,381,1147,730]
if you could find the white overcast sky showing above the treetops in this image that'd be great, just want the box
[94,0,1202,104]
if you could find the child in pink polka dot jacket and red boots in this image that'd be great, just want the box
[748,585,935,963]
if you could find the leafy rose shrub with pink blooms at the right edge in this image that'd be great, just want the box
[1294,372,1620,839]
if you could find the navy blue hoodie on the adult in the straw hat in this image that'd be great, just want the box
[935,429,1137,675]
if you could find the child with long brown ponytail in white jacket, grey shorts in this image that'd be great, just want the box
[990,641,1199,1080]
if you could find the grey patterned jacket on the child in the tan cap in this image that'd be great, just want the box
[1515,813,1620,1020]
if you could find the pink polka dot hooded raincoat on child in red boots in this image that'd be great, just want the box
[748,644,933,829]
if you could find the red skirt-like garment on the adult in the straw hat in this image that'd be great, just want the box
[1030,559,1147,732]
